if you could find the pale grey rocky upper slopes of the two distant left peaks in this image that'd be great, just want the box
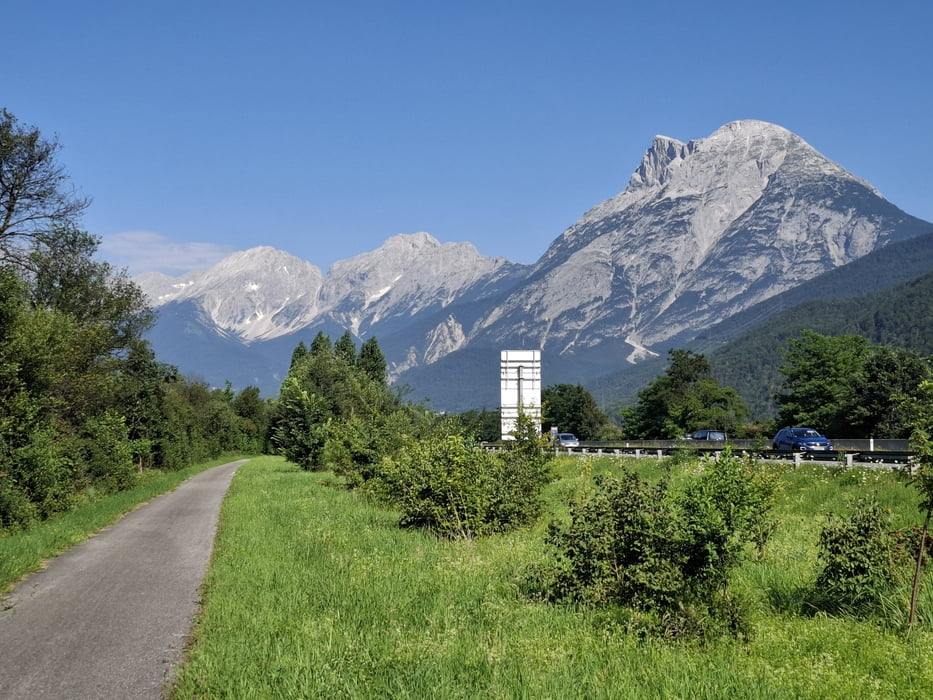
[136,233,526,343]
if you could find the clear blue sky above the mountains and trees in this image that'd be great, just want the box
[7,0,933,275]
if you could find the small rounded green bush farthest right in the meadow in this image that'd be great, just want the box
[813,499,905,614]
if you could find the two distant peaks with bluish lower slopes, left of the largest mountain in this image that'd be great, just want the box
[142,233,528,395]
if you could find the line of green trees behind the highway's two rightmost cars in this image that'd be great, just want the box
[620,329,933,439]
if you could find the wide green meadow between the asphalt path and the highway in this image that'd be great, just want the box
[175,457,933,698]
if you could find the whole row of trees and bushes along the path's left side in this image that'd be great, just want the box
[0,109,270,531]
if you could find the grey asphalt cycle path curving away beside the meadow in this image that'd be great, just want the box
[0,460,246,700]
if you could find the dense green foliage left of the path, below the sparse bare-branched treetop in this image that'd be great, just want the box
[0,260,265,529]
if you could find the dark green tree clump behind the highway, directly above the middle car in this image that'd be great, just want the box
[622,350,748,439]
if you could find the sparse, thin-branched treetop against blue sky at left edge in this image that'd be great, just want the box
[0,109,90,269]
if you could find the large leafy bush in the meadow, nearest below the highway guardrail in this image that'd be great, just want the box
[527,452,773,636]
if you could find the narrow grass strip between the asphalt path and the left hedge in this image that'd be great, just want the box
[0,456,251,594]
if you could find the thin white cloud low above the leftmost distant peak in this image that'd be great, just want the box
[99,231,233,277]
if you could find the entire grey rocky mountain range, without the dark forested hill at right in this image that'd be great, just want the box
[136,120,933,411]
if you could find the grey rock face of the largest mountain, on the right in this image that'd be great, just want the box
[470,121,928,361]
